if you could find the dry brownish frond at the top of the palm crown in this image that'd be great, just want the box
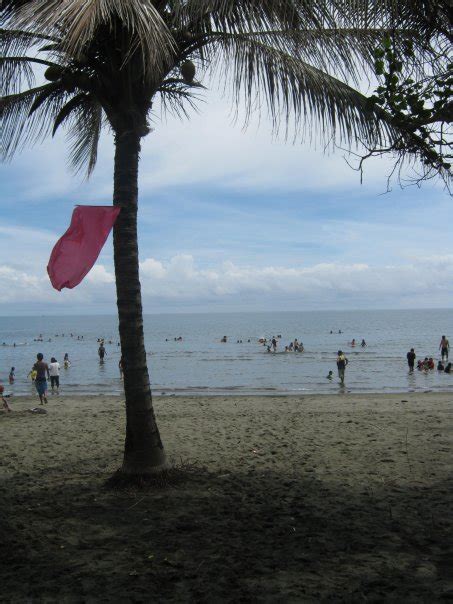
[8,0,174,71]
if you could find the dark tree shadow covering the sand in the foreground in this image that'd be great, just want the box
[1,470,453,602]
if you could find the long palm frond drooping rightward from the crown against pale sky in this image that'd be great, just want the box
[206,35,388,144]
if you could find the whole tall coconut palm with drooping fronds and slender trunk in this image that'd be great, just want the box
[1,0,440,475]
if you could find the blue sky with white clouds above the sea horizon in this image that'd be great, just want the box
[0,92,453,315]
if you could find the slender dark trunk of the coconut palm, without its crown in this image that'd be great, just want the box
[113,132,166,475]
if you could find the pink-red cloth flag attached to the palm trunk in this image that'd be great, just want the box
[47,206,120,291]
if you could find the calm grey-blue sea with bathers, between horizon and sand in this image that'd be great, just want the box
[0,309,453,400]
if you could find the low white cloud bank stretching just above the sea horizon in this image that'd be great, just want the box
[0,254,453,312]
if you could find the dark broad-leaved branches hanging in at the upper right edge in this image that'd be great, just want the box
[359,15,453,189]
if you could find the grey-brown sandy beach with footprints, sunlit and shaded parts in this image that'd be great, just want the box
[0,393,453,603]
